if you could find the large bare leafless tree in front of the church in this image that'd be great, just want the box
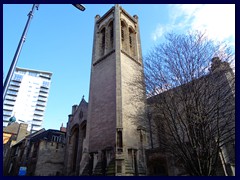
[142,32,235,176]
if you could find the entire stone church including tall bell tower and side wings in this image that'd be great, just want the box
[63,5,235,176]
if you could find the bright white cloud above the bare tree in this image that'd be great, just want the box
[152,4,235,45]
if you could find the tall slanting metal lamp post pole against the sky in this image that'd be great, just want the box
[3,4,39,101]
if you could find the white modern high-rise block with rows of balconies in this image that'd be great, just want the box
[3,67,52,132]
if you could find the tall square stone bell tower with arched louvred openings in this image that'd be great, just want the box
[84,5,147,176]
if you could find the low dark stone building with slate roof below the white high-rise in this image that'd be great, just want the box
[4,129,65,176]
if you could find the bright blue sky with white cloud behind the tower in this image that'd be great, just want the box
[3,4,235,129]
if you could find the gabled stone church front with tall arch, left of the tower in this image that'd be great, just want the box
[63,97,88,176]
